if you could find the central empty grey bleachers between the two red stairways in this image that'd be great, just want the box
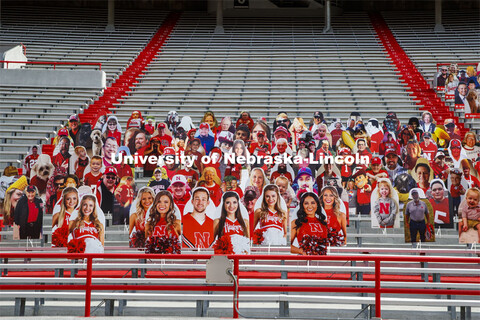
[115,12,418,127]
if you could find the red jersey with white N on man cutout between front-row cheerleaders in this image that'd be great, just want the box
[182,213,214,249]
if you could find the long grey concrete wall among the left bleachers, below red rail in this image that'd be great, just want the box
[0,69,107,89]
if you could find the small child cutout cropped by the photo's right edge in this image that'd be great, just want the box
[458,188,480,243]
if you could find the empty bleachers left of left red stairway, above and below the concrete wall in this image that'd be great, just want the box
[0,6,167,169]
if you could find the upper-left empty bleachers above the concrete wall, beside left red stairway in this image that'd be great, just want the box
[0,6,166,83]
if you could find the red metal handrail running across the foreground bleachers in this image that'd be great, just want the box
[0,252,480,318]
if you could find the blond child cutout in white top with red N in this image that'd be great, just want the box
[371,178,400,228]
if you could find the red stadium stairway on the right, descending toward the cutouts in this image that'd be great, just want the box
[370,13,468,135]
